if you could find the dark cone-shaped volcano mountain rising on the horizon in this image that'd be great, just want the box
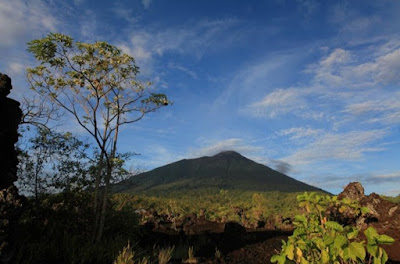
[113,151,321,193]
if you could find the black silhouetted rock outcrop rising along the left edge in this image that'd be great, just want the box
[0,73,22,263]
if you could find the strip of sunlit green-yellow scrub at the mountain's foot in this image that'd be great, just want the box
[112,189,299,227]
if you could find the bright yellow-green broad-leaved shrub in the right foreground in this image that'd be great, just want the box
[271,193,394,264]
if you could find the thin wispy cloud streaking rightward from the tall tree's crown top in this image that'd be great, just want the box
[117,19,237,74]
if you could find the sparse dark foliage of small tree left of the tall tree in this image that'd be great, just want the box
[17,127,91,196]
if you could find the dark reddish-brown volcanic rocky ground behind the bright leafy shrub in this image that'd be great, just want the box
[138,183,400,264]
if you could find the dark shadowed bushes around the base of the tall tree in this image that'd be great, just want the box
[12,190,139,263]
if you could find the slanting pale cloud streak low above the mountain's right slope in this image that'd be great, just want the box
[282,129,388,165]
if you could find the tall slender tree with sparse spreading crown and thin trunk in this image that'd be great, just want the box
[27,33,170,242]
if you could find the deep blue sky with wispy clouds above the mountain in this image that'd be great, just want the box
[0,0,400,195]
